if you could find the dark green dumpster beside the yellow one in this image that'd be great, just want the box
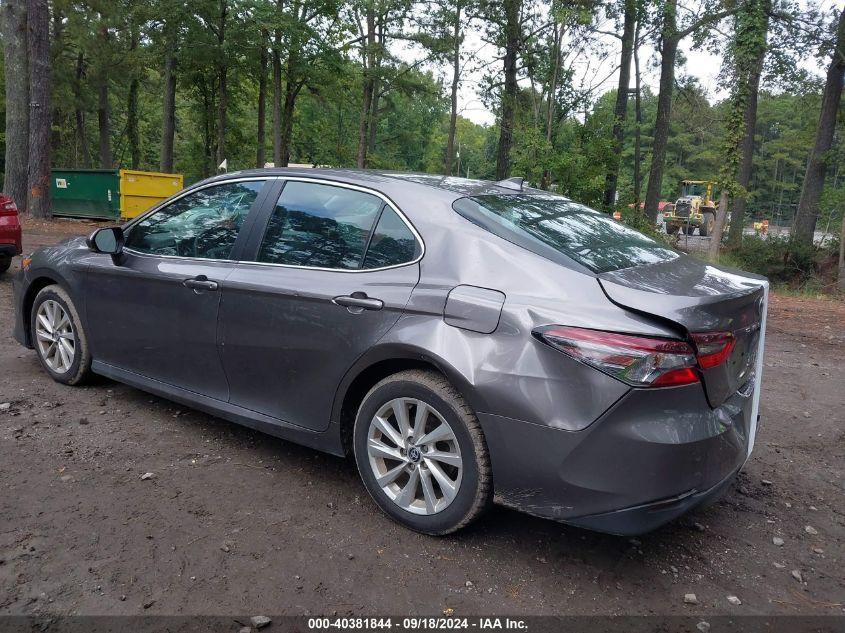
[50,169,120,220]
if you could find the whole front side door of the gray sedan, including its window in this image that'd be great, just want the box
[86,179,266,402]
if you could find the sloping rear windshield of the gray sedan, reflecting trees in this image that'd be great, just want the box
[452,194,678,273]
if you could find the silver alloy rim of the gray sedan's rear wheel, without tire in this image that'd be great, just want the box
[367,398,463,515]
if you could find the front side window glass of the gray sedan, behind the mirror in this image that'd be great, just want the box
[126,181,264,259]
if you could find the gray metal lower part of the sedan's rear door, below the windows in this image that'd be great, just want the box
[219,262,419,431]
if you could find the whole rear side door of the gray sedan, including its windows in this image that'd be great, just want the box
[220,179,423,430]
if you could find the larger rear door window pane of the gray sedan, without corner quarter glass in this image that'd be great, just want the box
[258,181,383,269]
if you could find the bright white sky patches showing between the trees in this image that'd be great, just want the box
[420,0,843,125]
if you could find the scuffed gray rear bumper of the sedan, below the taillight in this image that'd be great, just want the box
[479,384,753,534]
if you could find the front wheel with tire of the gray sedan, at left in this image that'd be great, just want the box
[29,285,91,385]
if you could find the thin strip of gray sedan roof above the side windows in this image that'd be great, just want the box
[204,167,548,198]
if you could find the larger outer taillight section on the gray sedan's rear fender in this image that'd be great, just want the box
[534,325,698,387]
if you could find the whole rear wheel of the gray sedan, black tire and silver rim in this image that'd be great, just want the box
[354,370,493,535]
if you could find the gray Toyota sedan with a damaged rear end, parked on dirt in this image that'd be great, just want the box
[14,169,768,534]
